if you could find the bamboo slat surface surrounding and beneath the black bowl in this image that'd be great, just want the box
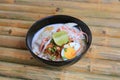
[0,0,120,80]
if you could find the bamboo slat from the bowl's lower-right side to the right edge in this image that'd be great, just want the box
[85,45,120,61]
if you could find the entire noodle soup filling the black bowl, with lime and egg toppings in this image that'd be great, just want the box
[32,23,87,61]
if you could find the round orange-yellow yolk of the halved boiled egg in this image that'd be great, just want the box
[64,47,76,59]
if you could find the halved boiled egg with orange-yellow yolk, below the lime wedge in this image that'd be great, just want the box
[61,42,80,60]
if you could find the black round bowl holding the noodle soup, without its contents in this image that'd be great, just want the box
[26,15,92,66]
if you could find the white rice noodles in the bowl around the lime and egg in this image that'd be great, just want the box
[32,23,87,61]
